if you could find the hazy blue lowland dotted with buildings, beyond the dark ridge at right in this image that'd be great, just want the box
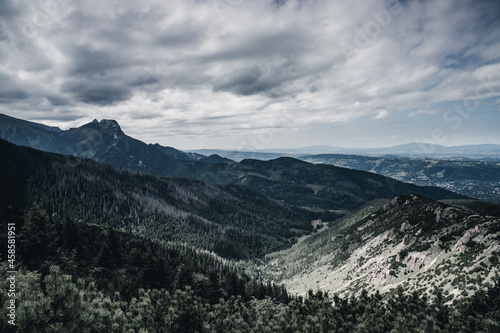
[298,154,500,201]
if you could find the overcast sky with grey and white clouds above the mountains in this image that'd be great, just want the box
[0,0,500,149]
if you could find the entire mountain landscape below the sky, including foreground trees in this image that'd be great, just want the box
[0,112,500,332]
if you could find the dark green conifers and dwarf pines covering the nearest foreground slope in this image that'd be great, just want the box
[0,205,500,333]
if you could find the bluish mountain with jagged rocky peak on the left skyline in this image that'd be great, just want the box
[0,115,203,174]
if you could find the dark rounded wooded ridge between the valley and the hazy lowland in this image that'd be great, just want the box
[190,157,464,210]
